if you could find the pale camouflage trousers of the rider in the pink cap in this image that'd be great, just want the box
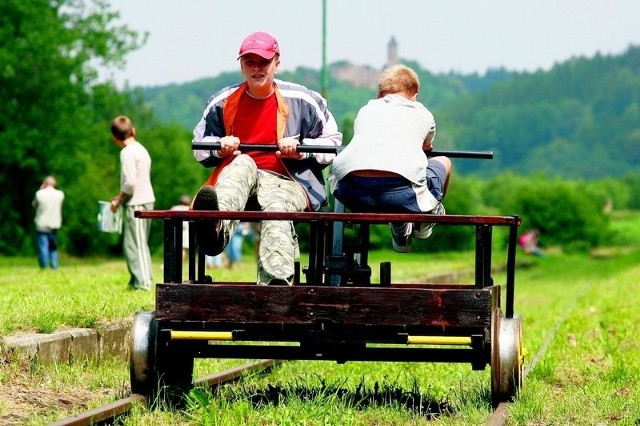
[215,154,307,284]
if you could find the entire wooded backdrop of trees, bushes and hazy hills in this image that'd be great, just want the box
[0,0,640,256]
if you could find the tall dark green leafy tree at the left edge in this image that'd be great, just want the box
[0,0,142,254]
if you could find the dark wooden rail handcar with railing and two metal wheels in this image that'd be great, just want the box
[132,210,523,402]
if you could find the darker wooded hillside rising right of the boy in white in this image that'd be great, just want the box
[438,46,640,179]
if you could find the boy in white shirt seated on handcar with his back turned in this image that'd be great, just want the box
[329,65,451,253]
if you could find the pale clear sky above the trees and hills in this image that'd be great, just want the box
[103,0,640,87]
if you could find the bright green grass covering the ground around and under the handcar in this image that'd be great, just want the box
[0,214,640,425]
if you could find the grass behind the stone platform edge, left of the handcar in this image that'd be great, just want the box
[0,257,162,336]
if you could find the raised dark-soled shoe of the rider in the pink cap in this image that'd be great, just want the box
[193,185,225,256]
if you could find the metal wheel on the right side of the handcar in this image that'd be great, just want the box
[491,313,524,407]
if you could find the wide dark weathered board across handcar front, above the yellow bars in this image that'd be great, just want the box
[156,283,499,328]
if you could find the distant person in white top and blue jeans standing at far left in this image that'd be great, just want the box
[32,176,64,269]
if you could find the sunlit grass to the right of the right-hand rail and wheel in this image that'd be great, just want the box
[512,249,640,424]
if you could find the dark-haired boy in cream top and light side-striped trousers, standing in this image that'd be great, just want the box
[111,115,156,290]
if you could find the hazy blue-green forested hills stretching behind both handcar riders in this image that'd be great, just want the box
[137,46,640,178]
